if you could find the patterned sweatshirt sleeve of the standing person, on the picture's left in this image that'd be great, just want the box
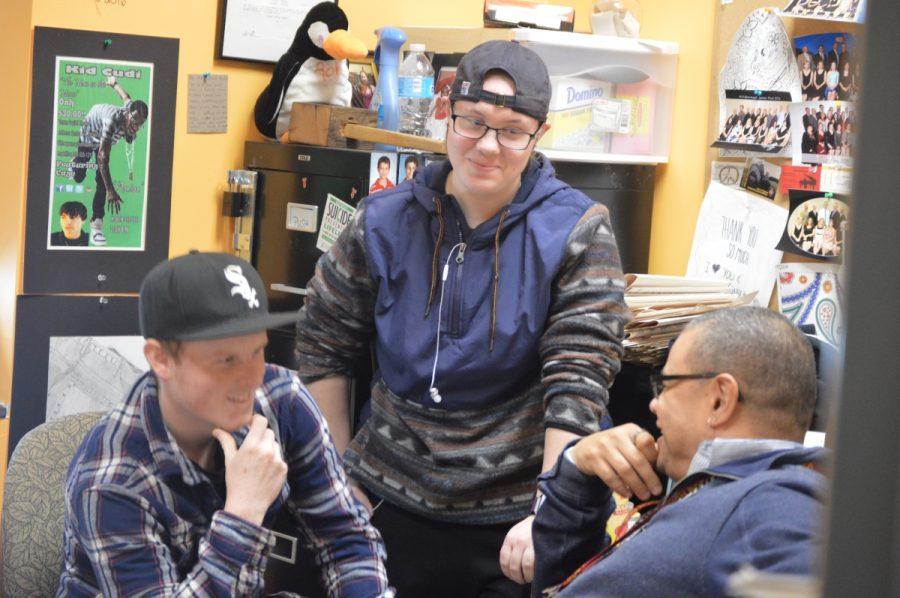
[295,205,376,383]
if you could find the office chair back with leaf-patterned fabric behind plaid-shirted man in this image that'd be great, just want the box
[0,412,103,598]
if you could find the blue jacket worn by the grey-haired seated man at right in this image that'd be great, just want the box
[533,447,826,598]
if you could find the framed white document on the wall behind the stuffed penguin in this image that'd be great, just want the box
[218,0,337,64]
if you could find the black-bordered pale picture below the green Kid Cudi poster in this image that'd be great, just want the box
[9,295,147,454]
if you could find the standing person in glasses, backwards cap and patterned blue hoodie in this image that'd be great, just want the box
[296,41,629,597]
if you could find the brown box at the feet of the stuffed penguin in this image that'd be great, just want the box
[288,102,378,149]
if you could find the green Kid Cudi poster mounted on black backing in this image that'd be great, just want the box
[23,27,178,294]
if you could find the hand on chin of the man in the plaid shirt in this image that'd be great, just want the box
[213,413,287,525]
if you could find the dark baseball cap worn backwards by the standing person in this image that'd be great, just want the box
[450,40,550,122]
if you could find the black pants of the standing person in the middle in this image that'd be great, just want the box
[372,500,531,598]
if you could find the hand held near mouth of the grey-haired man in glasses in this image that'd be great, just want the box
[571,424,662,500]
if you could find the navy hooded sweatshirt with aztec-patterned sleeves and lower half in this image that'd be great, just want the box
[296,154,628,524]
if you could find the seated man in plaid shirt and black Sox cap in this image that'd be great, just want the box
[58,252,391,597]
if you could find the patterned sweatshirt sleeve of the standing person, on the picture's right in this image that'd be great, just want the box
[540,204,630,434]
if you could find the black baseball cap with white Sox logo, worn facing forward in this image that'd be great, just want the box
[139,250,298,341]
